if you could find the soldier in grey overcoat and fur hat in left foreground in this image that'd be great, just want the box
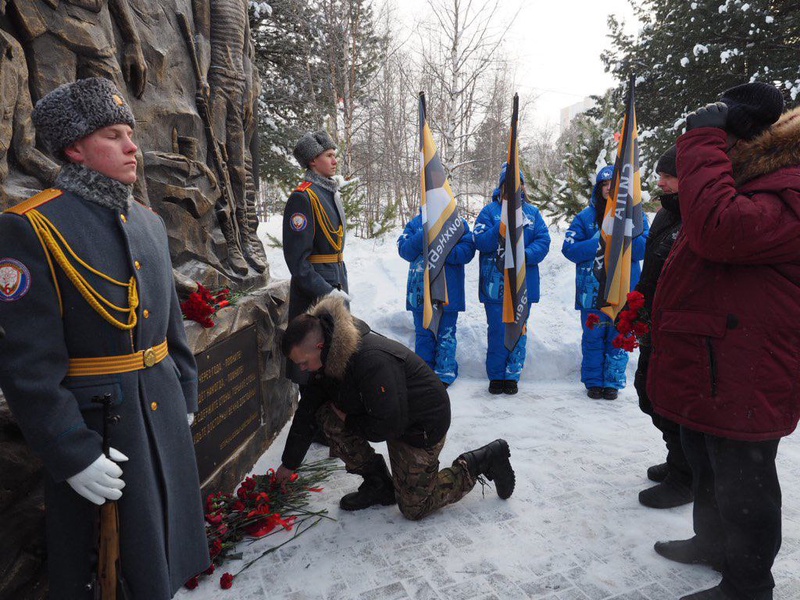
[0,78,210,600]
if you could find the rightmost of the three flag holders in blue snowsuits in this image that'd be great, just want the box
[561,166,650,400]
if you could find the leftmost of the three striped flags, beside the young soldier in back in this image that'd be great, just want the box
[419,92,464,335]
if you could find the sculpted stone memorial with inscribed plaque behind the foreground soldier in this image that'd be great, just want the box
[0,0,296,600]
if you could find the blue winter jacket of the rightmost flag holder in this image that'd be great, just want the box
[561,183,650,310]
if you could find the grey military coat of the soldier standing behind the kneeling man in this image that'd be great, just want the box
[283,182,348,321]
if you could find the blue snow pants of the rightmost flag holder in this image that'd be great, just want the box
[581,309,628,390]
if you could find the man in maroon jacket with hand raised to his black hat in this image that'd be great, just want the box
[647,83,800,600]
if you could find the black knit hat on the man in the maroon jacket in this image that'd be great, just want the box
[720,81,783,140]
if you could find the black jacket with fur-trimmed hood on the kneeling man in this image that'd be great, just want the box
[282,298,450,469]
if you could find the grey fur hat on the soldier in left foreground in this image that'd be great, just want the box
[31,77,136,159]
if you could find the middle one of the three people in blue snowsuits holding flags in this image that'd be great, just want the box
[473,163,550,394]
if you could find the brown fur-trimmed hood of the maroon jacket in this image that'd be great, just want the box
[728,107,800,187]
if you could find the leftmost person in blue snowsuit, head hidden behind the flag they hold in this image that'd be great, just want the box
[397,214,475,387]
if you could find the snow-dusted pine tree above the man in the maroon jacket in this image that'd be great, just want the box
[602,0,800,162]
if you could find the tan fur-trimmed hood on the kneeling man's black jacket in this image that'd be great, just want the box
[308,296,362,380]
